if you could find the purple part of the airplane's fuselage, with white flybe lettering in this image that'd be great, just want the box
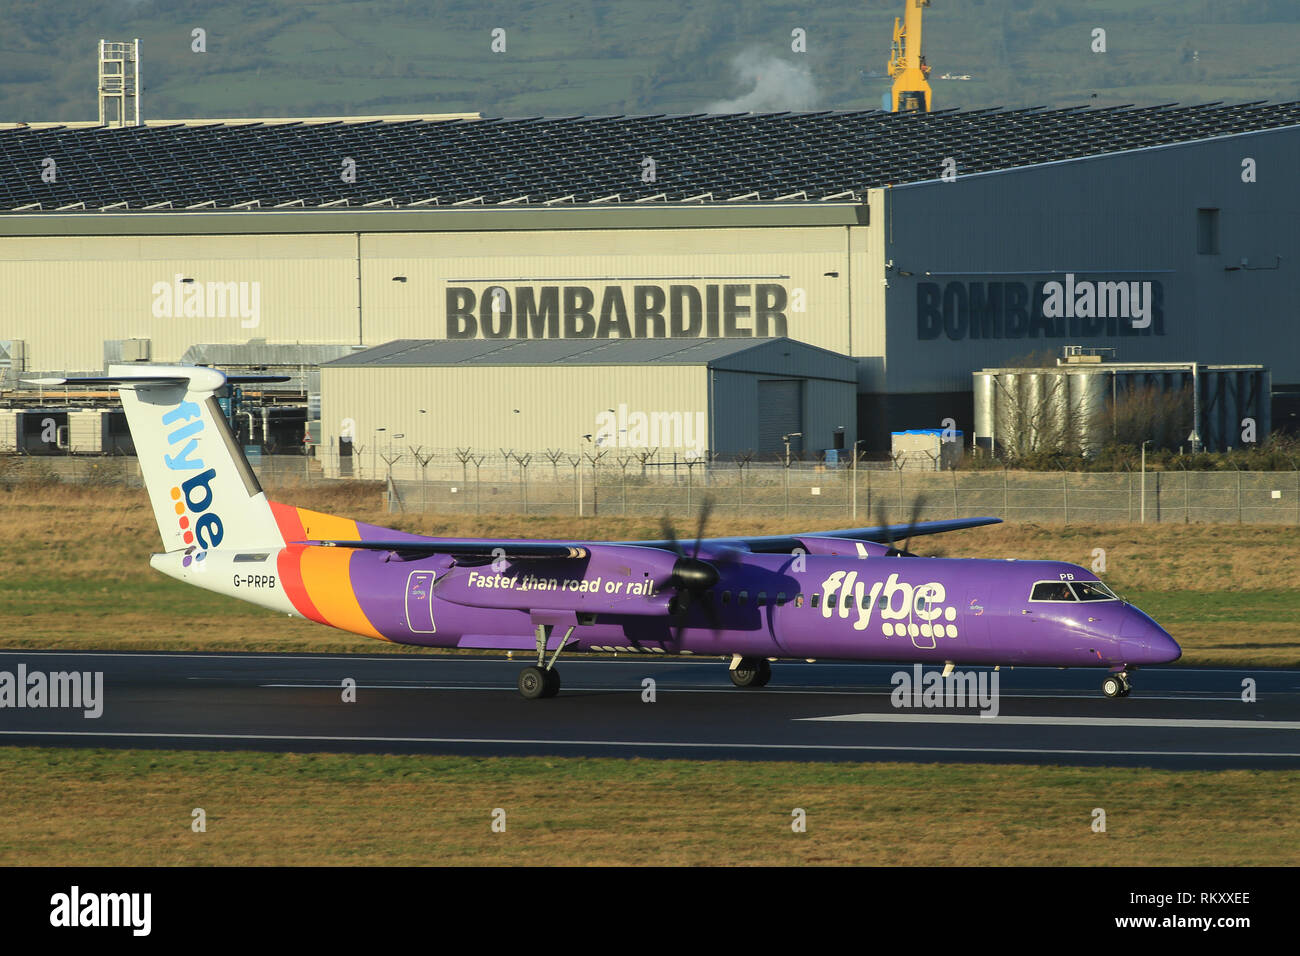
[350,544,1180,667]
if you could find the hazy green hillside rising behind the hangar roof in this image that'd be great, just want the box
[0,0,1300,121]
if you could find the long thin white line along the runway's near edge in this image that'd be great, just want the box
[0,730,1300,758]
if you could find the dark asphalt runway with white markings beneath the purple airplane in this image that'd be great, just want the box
[0,652,1300,769]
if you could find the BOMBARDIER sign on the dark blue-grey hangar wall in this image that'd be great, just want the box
[917,273,1165,341]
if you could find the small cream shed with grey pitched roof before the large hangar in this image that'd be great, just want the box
[321,338,858,475]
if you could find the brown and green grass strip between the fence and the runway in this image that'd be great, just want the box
[0,485,1300,666]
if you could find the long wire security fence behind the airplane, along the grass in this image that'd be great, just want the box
[0,454,1300,525]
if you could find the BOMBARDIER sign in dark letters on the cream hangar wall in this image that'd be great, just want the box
[447,282,789,338]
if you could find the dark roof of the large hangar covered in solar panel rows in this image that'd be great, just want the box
[0,103,1300,211]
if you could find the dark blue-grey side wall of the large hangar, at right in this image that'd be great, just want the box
[872,129,1300,393]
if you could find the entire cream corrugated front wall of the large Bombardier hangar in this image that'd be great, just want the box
[0,222,870,371]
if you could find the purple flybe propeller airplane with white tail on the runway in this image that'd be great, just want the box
[30,363,1182,700]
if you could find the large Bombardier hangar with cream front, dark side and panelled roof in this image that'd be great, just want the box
[0,103,1300,454]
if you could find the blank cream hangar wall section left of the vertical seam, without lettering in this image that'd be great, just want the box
[0,235,358,371]
